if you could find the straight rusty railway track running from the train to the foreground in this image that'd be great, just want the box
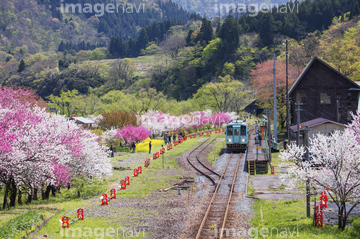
[196,153,242,239]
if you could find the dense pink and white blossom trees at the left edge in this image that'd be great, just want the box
[0,88,111,208]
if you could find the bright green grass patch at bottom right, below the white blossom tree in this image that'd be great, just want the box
[251,199,360,239]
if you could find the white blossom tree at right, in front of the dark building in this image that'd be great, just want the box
[280,129,360,229]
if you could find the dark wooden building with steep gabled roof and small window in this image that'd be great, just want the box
[288,57,360,125]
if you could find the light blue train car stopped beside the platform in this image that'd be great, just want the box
[225,121,249,152]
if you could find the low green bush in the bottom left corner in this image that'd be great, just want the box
[0,211,41,239]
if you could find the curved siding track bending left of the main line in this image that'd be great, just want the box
[187,139,221,185]
